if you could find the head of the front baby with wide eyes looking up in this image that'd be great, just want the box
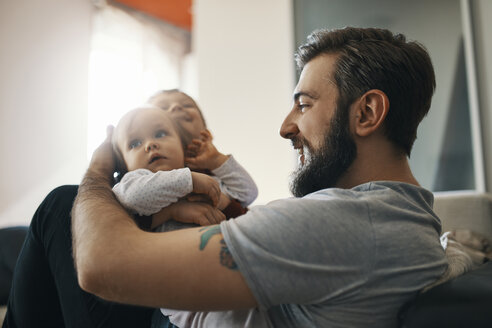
[112,105,190,177]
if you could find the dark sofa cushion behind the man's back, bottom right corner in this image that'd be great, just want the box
[399,262,492,328]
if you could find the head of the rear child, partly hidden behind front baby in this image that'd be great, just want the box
[148,89,207,138]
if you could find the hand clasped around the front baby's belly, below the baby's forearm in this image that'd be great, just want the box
[152,200,226,227]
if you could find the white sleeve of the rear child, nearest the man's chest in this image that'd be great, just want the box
[212,155,258,207]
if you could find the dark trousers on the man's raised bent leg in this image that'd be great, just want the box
[3,186,156,328]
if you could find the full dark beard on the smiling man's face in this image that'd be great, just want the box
[290,106,357,197]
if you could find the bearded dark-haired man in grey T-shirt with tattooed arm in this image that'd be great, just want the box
[73,28,446,327]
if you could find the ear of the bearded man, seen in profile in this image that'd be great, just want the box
[354,89,390,137]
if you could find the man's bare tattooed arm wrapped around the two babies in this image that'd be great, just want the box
[72,127,256,310]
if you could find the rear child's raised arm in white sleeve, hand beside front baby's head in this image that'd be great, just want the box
[186,130,258,207]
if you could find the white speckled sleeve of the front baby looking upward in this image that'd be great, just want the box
[113,168,193,215]
